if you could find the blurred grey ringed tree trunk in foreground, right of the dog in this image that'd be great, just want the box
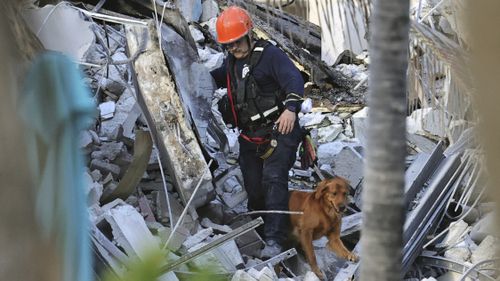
[360,0,409,281]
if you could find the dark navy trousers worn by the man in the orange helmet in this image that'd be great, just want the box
[239,122,303,244]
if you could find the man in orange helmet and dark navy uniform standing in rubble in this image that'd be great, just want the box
[211,6,304,258]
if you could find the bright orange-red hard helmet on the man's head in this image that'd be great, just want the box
[215,6,253,44]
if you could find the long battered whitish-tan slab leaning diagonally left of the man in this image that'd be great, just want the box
[125,21,214,207]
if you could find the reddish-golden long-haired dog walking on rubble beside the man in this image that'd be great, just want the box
[288,177,358,279]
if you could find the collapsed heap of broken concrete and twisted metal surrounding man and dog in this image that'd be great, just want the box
[14,0,497,281]
